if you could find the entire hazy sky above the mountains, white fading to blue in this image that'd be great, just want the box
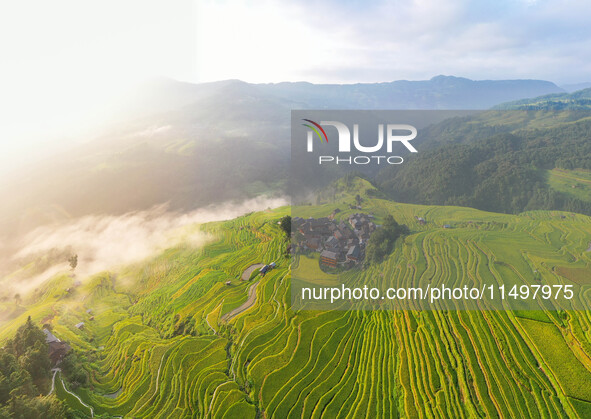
[0,0,591,172]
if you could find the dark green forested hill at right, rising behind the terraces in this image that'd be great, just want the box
[377,111,591,214]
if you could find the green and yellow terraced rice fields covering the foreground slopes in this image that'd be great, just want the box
[2,189,591,418]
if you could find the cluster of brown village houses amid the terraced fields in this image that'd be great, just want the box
[292,213,379,268]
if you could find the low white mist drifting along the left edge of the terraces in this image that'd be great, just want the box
[6,197,289,292]
